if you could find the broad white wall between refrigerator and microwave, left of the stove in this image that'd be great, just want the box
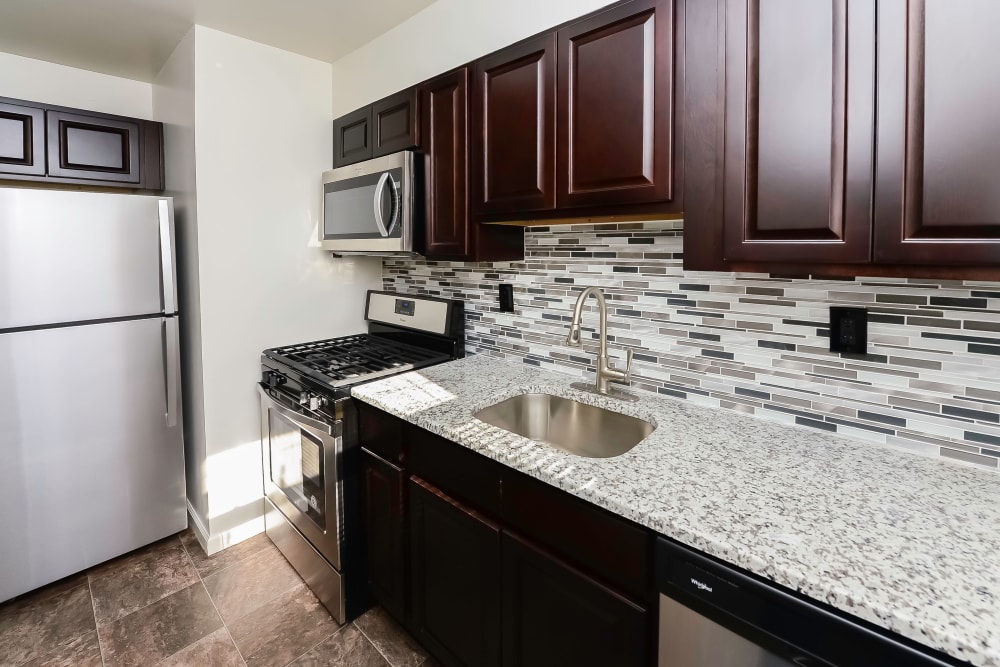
[192,26,381,541]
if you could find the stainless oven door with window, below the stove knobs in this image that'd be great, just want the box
[257,385,344,570]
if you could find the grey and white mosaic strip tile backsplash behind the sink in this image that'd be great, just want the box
[382,221,1000,469]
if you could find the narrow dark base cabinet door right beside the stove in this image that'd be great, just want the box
[361,449,406,622]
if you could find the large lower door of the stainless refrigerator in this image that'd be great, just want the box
[0,317,187,601]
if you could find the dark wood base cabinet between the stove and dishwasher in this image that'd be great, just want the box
[358,404,657,667]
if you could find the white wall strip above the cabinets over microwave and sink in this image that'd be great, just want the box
[333,0,613,118]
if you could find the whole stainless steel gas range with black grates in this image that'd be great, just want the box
[258,291,464,623]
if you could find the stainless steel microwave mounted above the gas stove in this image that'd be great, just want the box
[319,151,421,255]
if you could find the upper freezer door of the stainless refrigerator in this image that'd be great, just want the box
[0,188,174,331]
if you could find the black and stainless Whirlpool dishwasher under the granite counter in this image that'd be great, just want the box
[656,538,968,667]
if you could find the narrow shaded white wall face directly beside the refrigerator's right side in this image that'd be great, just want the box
[153,28,208,532]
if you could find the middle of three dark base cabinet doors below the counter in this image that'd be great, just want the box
[409,477,500,667]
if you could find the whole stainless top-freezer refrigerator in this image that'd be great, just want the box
[0,187,187,601]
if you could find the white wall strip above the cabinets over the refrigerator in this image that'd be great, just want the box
[0,52,153,118]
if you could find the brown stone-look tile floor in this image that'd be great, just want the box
[0,530,437,667]
